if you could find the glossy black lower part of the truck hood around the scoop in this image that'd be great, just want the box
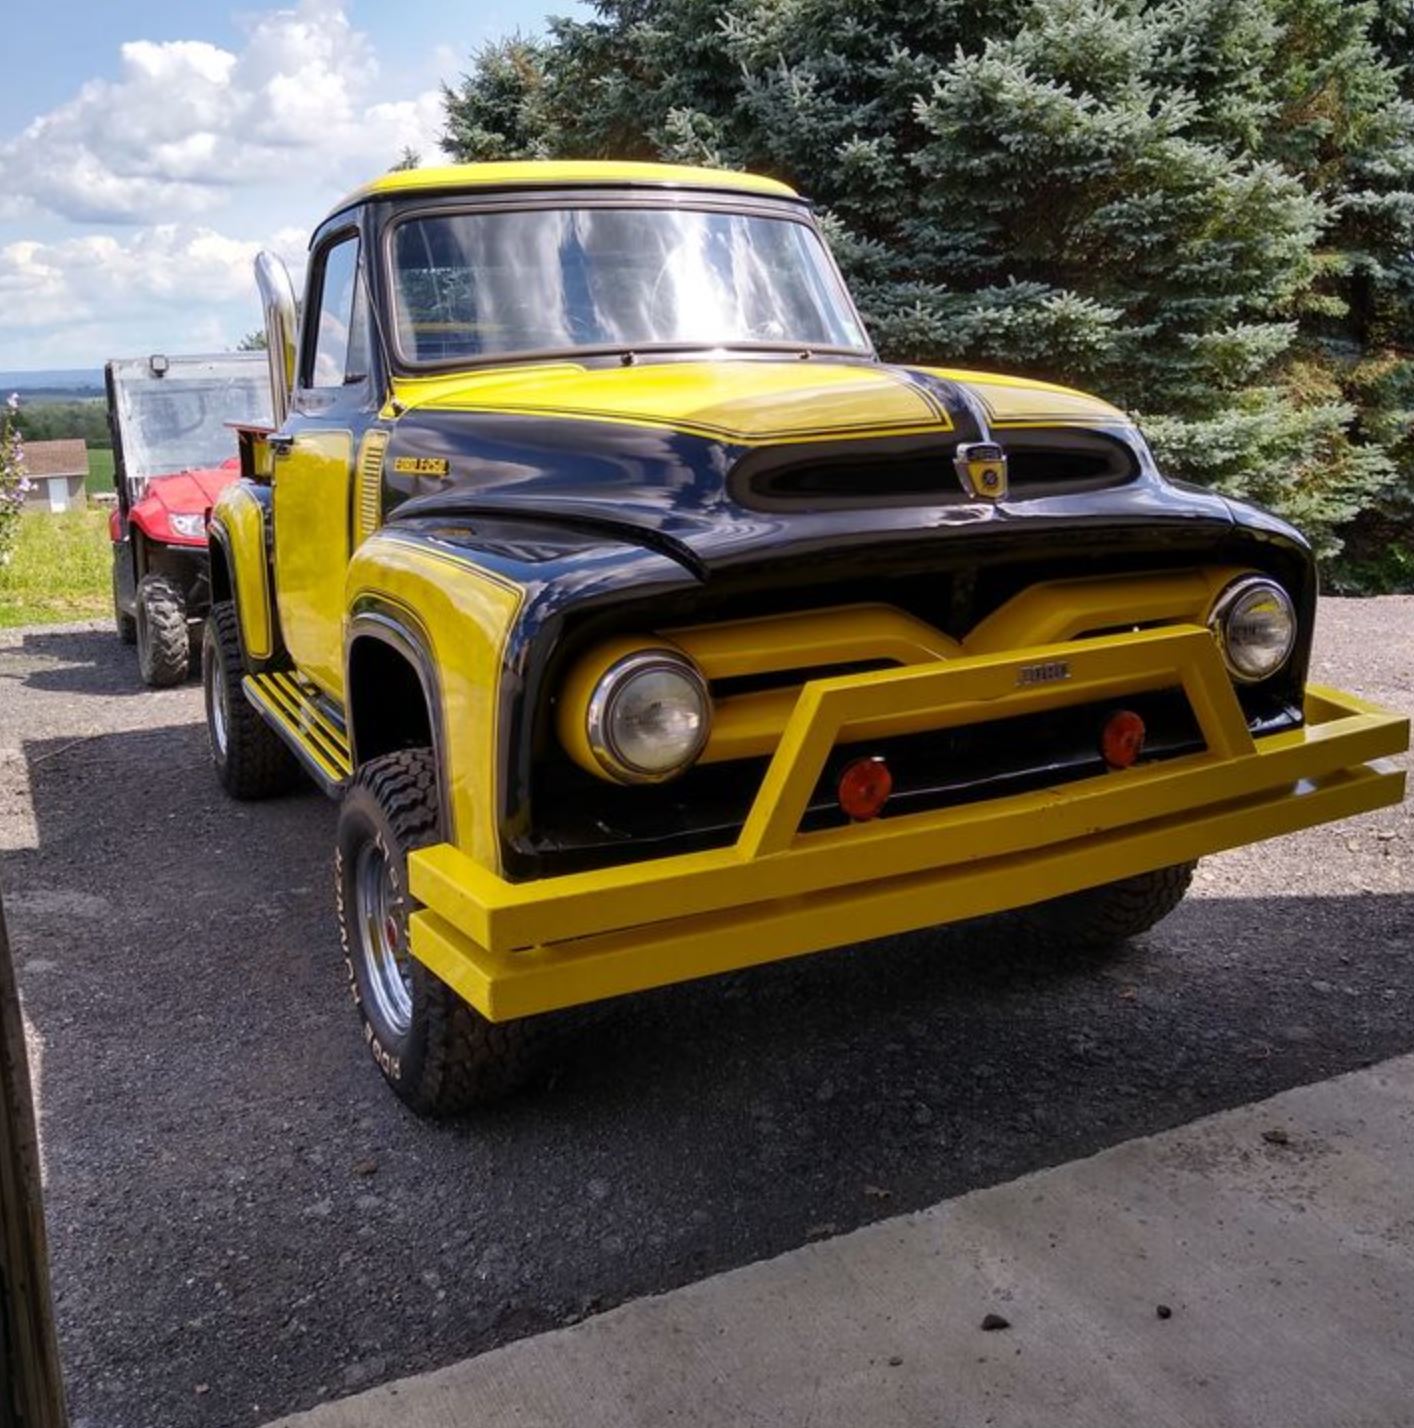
[384,399,1274,581]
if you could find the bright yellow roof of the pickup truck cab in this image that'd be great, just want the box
[331,159,800,225]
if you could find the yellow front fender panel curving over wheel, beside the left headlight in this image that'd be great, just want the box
[344,527,524,871]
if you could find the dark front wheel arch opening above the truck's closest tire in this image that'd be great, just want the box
[344,594,453,838]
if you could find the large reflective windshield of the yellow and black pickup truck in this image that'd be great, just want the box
[391,207,868,363]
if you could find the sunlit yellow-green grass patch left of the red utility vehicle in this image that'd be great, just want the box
[0,508,113,627]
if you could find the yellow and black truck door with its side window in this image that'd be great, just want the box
[271,231,371,698]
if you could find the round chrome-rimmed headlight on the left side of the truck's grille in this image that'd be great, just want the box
[586,650,711,784]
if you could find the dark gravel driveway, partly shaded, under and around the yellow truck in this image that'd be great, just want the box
[0,598,1414,1428]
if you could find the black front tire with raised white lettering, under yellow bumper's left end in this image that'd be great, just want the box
[334,748,547,1117]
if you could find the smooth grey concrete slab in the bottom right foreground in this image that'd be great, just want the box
[271,1057,1414,1428]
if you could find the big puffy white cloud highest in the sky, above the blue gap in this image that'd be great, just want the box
[0,0,443,224]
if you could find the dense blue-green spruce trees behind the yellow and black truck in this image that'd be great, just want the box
[444,0,1414,587]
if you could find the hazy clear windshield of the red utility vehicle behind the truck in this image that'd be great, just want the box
[113,353,270,496]
